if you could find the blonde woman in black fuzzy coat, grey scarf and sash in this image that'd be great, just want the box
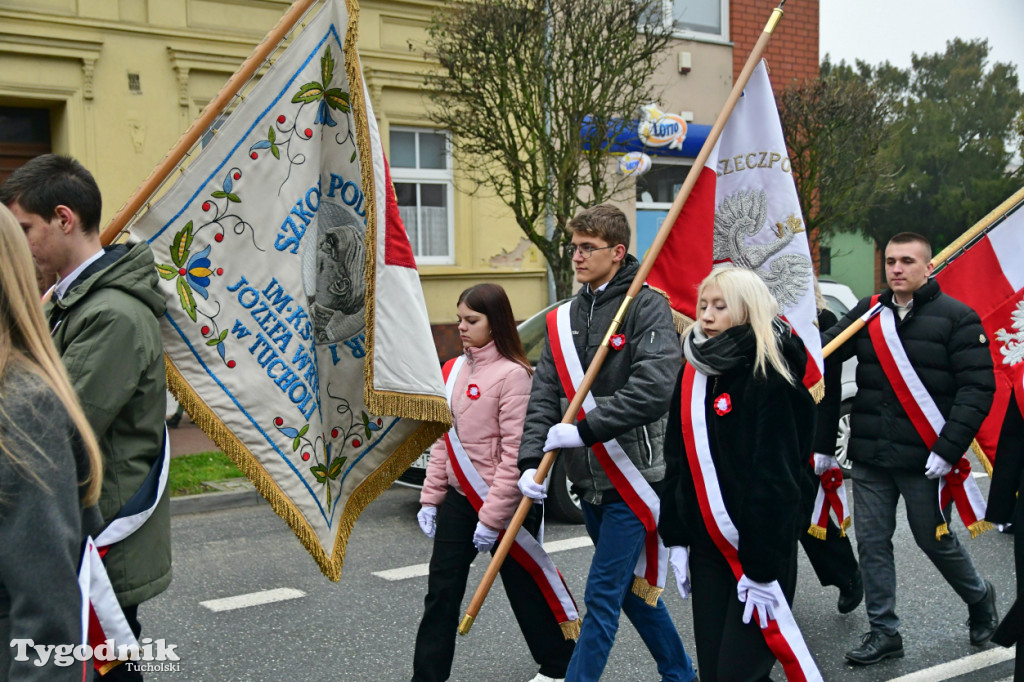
[658,268,820,680]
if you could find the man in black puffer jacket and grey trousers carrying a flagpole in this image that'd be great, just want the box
[823,232,998,665]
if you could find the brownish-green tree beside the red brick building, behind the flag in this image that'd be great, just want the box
[778,55,894,249]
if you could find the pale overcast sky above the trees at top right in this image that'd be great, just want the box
[815,0,1024,73]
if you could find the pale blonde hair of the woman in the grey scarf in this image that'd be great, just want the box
[691,267,794,384]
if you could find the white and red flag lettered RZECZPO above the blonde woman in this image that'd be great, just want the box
[647,61,824,391]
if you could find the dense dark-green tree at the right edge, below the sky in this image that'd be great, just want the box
[858,38,1024,250]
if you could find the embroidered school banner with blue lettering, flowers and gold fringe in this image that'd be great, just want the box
[132,0,451,581]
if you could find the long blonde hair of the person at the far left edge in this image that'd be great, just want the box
[0,199,102,507]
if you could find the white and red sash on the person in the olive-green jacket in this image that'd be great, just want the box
[78,427,171,675]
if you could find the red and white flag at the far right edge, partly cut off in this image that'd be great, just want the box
[936,199,1024,462]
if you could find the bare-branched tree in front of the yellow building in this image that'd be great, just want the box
[426,0,670,298]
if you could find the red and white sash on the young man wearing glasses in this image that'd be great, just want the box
[547,302,669,606]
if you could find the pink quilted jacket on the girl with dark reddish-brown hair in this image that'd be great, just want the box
[420,341,531,529]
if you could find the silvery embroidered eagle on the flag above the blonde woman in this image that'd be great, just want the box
[715,189,814,313]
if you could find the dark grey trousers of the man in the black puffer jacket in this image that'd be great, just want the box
[853,463,986,635]
